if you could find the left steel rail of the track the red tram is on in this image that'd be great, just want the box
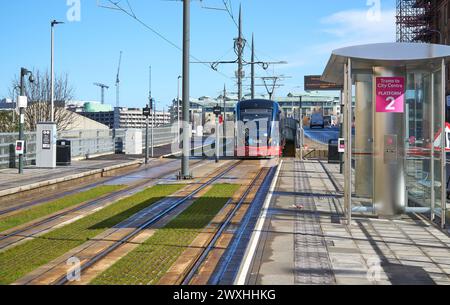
[51,160,244,285]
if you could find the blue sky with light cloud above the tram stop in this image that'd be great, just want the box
[0,0,395,108]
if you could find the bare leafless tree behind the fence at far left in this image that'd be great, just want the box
[10,70,75,131]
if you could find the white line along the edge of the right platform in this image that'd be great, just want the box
[234,160,283,286]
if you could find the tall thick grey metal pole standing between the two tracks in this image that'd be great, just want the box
[180,0,191,179]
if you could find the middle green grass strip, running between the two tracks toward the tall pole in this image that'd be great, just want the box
[0,185,185,284]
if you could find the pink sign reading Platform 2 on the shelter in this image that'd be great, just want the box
[376,77,405,113]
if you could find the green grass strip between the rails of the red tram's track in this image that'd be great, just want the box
[91,184,239,285]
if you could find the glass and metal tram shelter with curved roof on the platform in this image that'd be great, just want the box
[322,43,450,227]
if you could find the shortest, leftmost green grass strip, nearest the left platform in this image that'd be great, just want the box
[0,185,123,232]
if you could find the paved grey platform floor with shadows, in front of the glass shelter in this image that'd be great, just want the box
[247,159,450,285]
